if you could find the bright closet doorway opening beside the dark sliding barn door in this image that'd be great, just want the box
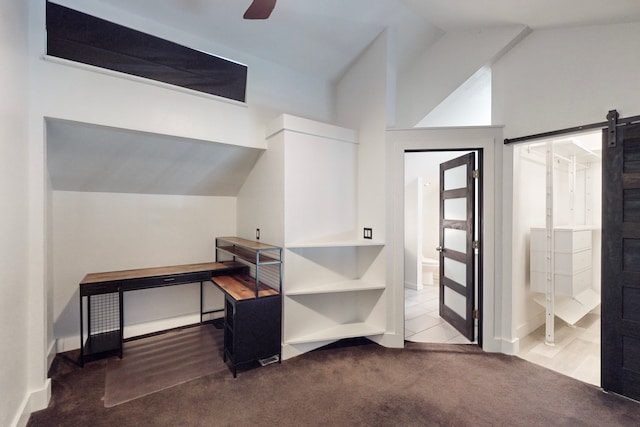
[512,130,602,386]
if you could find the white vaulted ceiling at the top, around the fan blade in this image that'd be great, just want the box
[91,0,640,80]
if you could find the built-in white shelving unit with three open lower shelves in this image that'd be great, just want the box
[238,115,387,359]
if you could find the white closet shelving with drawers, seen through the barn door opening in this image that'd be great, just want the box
[529,139,601,344]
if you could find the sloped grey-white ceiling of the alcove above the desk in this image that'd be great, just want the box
[47,119,263,196]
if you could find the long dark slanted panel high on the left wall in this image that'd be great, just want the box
[46,2,247,102]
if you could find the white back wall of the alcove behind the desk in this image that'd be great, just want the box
[52,191,236,352]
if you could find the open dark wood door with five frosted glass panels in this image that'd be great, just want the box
[438,153,475,341]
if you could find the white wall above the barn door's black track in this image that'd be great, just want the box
[492,23,640,138]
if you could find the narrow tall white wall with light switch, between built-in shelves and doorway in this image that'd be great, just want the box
[335,29,396,347]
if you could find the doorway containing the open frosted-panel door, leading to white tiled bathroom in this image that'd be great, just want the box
[404,150,482,344]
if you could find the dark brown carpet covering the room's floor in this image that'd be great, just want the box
[29,336,640,426]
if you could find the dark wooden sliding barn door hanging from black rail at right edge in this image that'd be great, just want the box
[602,120,640,400]
